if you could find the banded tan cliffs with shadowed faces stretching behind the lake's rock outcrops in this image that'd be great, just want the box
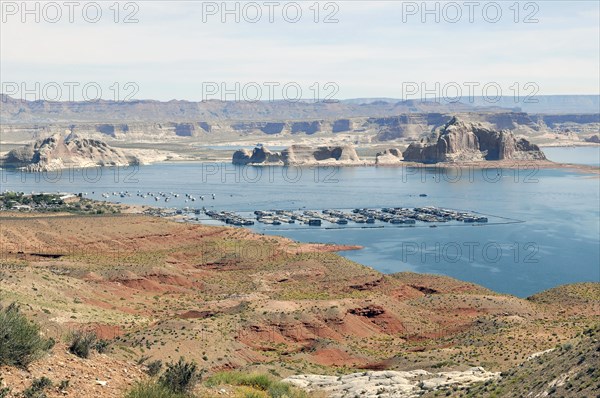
[0,108,600,143]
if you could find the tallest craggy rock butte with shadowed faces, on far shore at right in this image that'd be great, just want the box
[403,117,546,163]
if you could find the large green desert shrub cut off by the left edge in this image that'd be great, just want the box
[0,303,54,368]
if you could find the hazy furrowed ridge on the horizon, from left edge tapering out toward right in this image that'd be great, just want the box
[0,95,490,124]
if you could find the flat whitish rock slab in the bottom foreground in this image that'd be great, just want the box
[283,367,500,398]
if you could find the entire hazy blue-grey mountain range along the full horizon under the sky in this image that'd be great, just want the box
[0,94,600,124]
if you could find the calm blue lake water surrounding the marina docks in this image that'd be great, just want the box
[1,148,600,297]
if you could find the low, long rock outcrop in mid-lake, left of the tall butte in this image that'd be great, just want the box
[232,145,361,166]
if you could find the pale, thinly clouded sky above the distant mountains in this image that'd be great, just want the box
[0,0,600,102]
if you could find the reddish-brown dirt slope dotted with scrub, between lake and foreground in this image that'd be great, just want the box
[0,215,600,396]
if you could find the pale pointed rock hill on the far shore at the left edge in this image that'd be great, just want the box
[0,133,139,172]
